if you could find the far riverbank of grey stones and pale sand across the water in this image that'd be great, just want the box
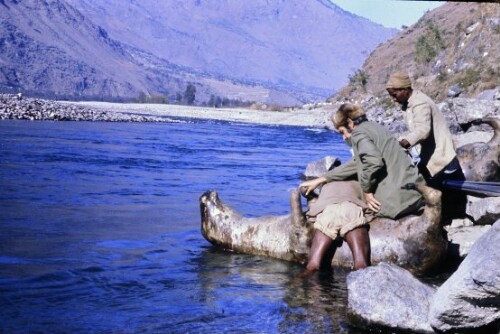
[0,94,331,128]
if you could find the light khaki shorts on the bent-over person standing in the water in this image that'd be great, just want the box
[314,202,367,240]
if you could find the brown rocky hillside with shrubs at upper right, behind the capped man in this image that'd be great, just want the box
[332,2,500,104]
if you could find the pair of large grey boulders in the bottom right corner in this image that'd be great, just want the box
[347,221,500,334]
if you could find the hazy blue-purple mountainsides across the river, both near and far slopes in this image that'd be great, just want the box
[0,0,396,105]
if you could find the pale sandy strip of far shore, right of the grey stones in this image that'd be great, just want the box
[71,101,330,128]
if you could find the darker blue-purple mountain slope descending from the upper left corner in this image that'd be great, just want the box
[0,0,183,98]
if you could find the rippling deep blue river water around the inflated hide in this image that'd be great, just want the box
[0,120,372,333]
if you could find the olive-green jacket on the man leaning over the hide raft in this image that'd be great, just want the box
[323,122,425,219]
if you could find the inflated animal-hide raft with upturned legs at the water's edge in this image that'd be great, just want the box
[200,185,448,274]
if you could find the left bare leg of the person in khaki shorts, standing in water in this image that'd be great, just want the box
[306,230,336,272]
